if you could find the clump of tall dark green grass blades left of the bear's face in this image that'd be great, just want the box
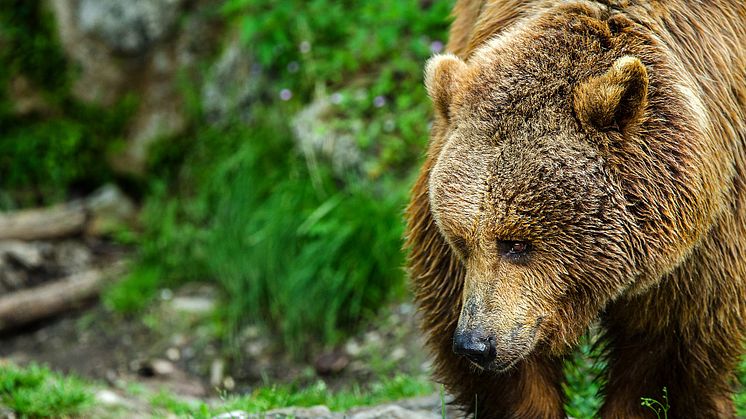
[207,136,403,352]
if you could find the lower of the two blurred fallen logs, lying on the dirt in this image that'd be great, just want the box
[0,263,124,331]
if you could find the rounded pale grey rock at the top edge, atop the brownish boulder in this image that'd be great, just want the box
[77,0,184,54]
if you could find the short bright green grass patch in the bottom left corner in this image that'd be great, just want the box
[0,363,93,417]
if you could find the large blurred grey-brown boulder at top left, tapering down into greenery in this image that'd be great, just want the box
[48,0,222,175]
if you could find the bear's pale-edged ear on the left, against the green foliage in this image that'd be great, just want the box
[425,54,466,120]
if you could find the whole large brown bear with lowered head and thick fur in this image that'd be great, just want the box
[407,0,746,419]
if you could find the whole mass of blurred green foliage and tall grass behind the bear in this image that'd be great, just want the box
[103,0,450,353]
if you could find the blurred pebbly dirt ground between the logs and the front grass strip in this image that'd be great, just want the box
[0,278,428,399]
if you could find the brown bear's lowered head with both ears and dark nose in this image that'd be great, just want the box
[418,6,716,371]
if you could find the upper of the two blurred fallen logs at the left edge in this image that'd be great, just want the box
[0,201,87,240]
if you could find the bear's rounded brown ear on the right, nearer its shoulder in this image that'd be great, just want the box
[573,56,648,131]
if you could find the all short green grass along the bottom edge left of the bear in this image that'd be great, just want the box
[0,364,435,418]
